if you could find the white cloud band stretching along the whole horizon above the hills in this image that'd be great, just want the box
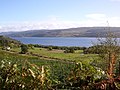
[0,13,120,32]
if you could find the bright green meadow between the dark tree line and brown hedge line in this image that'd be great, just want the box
[29,48,97,61]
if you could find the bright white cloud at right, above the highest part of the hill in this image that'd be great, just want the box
[85,14,120,27]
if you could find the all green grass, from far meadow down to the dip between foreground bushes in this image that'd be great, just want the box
[0,45,107,88]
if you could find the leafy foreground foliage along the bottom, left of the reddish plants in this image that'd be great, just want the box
[0,60,107,90]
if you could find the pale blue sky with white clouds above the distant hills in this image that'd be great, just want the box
[0,0,120,32]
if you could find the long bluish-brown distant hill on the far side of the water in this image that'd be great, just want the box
[3,27,120,37]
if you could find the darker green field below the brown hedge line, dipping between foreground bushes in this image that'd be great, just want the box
[0,50,75,86]
